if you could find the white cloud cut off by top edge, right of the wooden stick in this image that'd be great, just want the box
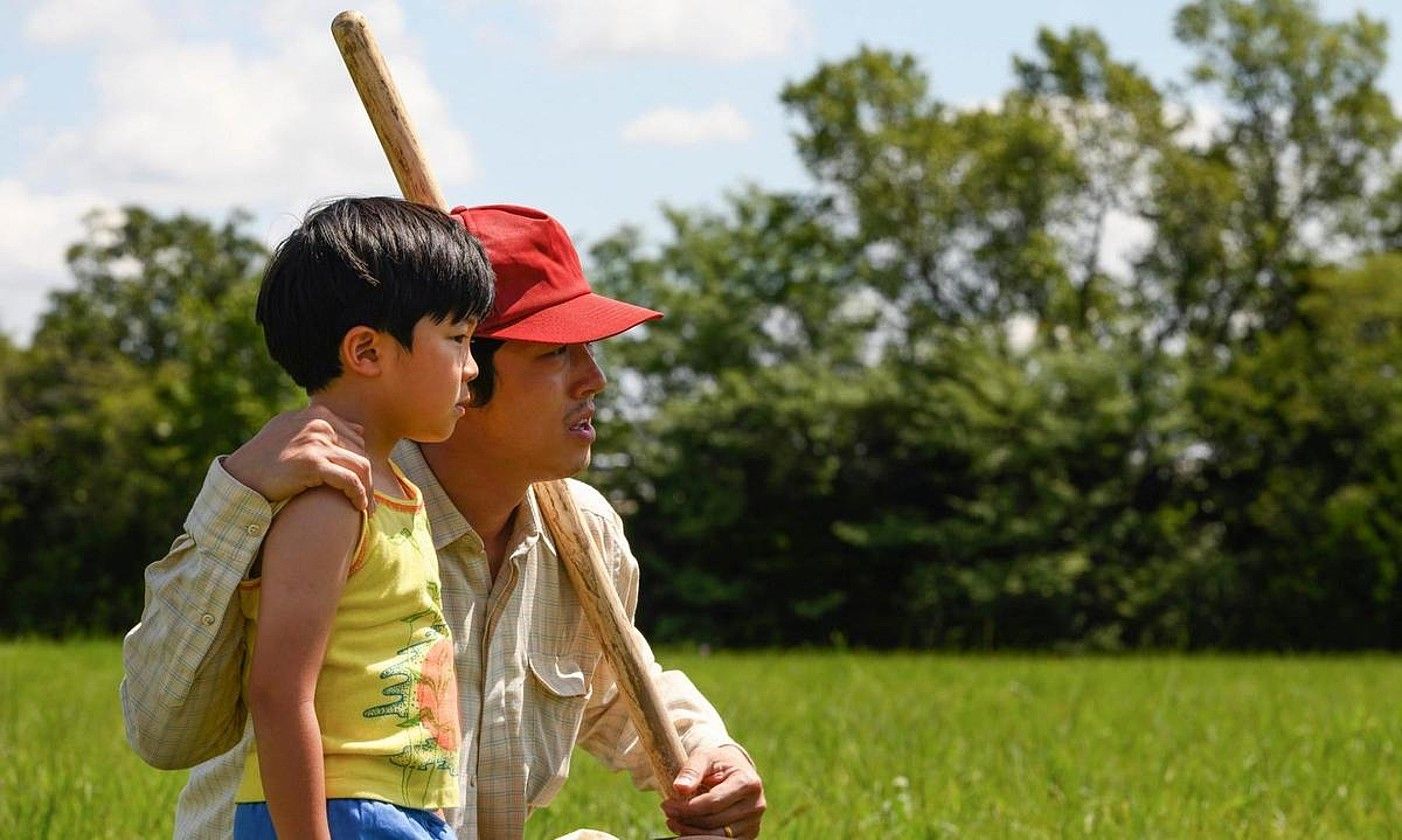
[534,0,806,62]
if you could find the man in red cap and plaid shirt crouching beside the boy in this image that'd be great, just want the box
[122,206,764,839]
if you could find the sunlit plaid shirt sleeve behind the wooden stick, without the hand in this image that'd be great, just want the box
[579,490,753,790]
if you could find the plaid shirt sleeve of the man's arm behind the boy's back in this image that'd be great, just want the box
[121,460,273,770]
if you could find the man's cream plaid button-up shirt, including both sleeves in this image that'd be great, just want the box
[122,443,735,839]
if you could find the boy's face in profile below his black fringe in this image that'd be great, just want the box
[388,317,477,443]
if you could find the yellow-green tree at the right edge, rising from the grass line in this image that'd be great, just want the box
[1196,254,1402,648]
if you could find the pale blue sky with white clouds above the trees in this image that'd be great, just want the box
[0,0,1402,341]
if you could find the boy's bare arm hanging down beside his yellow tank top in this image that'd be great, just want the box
[248,488,362,840]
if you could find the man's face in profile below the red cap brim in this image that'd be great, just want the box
[458,341,607,481]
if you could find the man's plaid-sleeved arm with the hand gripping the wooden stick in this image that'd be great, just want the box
[569,481,765,837]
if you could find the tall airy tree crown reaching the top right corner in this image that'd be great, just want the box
[1147,0,1402,349]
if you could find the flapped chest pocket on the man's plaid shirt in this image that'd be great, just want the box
[522,651,600,808]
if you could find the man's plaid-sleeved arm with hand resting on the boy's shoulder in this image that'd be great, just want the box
[121,408,372,770]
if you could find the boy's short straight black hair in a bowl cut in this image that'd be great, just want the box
[257,198,495,394]
